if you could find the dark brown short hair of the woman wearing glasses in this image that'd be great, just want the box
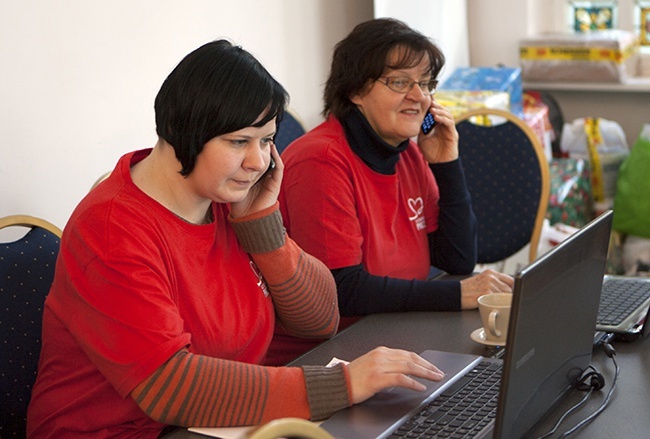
[323,18,445,118]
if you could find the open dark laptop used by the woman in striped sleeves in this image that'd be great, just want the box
[321,211,613,439]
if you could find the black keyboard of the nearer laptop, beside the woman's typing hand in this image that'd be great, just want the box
[389,361,502,439]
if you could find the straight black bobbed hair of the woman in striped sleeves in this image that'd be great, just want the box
[154,40,289,176]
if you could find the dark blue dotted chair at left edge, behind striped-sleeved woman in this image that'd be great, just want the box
[0,215,61,439]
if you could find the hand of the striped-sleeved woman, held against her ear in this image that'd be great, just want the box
[230,144,284,218]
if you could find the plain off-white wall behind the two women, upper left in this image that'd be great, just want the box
[0,0,373,227]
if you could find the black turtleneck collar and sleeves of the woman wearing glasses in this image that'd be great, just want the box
[332,109,477,317]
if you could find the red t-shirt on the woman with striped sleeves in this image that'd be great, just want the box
[28,151,274,437]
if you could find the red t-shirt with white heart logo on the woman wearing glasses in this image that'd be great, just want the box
[280,117,439,280]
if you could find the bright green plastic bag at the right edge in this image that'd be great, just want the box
[612,124,650,238]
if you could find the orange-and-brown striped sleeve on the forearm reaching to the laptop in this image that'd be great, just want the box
[131,349,349,427]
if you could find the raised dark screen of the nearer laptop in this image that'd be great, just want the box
[494,211,613,438]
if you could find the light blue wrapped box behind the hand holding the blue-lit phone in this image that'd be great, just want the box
[436,67,523,117]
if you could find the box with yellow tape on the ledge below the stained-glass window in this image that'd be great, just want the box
[519,29,639,82]
